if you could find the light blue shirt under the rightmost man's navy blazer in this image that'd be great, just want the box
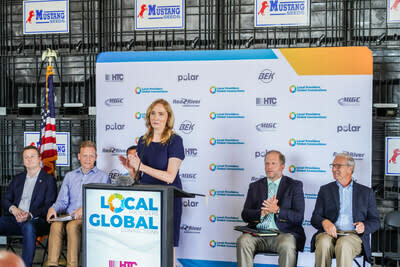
[335,180,355,231]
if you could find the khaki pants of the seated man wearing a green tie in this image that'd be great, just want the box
[236,233,297,267]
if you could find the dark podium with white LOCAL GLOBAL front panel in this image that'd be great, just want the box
[82,184,195,267]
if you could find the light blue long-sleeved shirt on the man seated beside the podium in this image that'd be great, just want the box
[52,167,110,214]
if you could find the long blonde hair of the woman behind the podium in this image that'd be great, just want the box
[143,99,175,146]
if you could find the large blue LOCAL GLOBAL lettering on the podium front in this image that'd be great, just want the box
[88,193,159,230]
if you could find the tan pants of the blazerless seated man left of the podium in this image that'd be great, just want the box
[48,220,82,267]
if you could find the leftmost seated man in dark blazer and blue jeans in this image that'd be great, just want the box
[0,146,57,267]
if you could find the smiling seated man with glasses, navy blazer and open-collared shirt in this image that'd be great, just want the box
[311,153,380,267]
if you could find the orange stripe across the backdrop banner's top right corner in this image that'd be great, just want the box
[280,47,373,75]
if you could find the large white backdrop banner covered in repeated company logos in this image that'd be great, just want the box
[96,47,372,267]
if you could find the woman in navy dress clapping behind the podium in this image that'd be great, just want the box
[128,99,185,264]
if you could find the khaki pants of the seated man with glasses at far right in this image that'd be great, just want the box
[315,233,362,267]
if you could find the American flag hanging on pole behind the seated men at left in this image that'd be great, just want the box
[39,66,57,177]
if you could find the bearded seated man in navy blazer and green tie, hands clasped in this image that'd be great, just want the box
[236,150,306,267]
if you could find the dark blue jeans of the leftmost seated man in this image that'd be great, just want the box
[0,216,50,267]
